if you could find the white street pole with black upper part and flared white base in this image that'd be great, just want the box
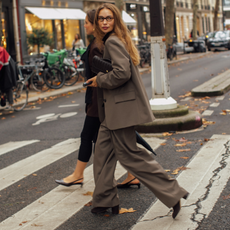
[149,0,177,110]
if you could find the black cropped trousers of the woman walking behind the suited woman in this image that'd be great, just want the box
[78,116,101,162]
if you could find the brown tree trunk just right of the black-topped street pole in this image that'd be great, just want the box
[165,0,175,47]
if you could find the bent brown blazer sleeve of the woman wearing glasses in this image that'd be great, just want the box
[97,36,131,89]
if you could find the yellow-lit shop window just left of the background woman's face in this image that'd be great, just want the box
[63,20,80,50]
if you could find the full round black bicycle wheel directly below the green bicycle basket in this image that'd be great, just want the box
[43,67,65,89]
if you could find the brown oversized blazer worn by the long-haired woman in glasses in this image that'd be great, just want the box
[97,34,155,130]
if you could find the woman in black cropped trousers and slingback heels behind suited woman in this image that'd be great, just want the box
[55,10,140,188]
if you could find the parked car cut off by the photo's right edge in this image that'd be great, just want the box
[207,31,230,51]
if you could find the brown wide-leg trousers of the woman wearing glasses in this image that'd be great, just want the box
[93,122,187,208]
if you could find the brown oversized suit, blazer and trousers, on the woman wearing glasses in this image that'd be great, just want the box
[93,33,188,208]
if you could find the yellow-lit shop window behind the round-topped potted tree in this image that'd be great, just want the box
[25,12,54,55]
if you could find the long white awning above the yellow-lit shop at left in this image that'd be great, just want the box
[26,7,86,20]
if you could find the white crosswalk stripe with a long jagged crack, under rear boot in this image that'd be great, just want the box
[132,135,230,230]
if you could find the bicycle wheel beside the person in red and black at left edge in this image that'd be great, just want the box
[12,81,29,112]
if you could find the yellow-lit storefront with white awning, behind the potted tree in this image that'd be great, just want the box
[19,0,85,60]
